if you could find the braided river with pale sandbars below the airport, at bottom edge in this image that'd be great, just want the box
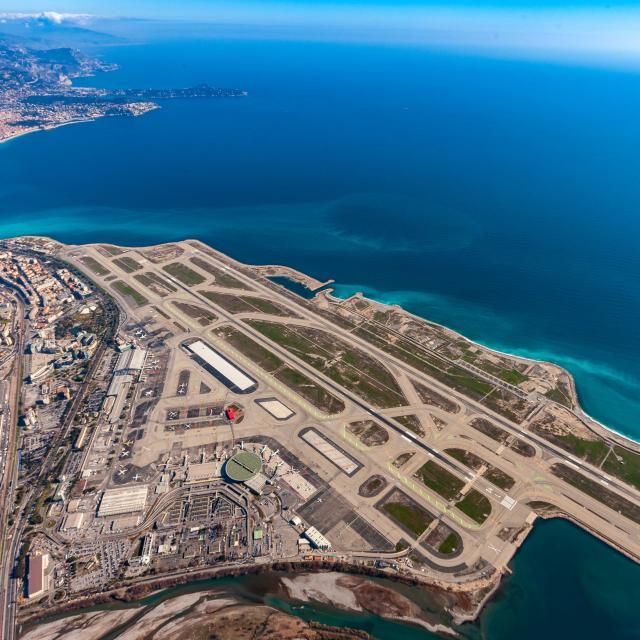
[20,571,460,640]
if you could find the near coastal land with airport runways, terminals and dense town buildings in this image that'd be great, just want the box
[0,237,640,638]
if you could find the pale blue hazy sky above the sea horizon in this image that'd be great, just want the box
[0,0,640,68]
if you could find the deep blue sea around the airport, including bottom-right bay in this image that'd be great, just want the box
[0,28,640,640]
